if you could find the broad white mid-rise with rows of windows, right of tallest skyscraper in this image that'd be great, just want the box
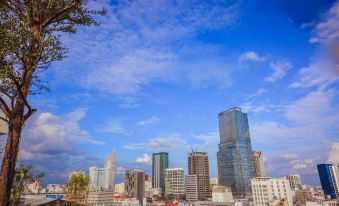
[251,177,293,206]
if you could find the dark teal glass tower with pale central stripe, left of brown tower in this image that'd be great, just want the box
[152,152,168,193]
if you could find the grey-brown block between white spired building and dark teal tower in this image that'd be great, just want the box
[124,170,145,205]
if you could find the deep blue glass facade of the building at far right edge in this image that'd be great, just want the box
[317,164,337,199]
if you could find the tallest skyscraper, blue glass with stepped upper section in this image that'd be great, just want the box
[217,107,254,198]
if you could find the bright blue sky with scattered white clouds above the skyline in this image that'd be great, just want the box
[15,0,339,184]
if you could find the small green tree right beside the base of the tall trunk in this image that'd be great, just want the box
[10,164,44,206]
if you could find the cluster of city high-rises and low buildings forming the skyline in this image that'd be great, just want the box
[17,107,339,206]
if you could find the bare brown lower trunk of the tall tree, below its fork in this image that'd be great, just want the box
[0,117,23,206]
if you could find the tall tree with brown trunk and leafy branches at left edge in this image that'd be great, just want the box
[0,0,106,205]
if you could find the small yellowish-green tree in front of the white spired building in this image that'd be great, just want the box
[65,173,90,203]
